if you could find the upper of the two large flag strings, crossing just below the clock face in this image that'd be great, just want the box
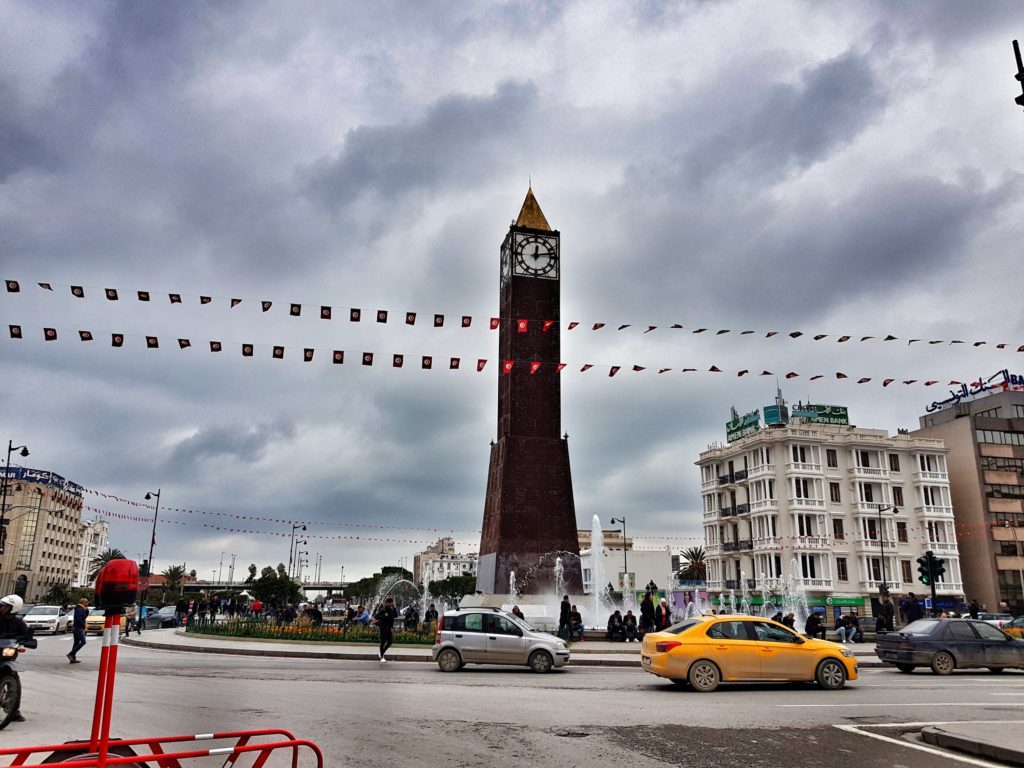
[5,280,1024,352]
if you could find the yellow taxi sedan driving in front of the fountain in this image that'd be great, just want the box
[640,614,857,693]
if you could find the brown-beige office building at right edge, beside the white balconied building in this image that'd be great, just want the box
[912,385,1024,613]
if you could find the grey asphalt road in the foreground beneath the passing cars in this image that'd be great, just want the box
[6,630,1024,768]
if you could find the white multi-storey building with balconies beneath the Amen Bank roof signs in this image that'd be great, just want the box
[697,409,964,618]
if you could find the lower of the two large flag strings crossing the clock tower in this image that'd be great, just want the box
[8,325,1024,390]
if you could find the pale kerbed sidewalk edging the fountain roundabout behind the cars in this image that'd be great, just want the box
[121,630,888,669]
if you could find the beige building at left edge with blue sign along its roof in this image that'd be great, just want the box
[0,467,82,602]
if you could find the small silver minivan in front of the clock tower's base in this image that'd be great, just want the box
[432,608,569,672]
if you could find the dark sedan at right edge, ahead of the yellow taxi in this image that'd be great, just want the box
[874,618,1024,675]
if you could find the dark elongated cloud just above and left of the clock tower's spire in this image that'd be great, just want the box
[305,82,538,208]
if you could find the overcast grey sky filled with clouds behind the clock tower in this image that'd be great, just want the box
[0,0,1024,579]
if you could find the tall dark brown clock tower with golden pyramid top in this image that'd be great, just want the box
[476,188,583,594]
